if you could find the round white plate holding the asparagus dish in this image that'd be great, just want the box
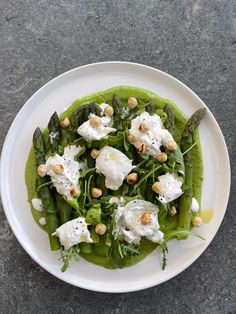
[1,62,230,292]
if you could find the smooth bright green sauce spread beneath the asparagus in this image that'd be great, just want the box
[25,86,203,268]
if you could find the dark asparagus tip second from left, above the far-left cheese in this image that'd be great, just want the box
[48,112,60,154]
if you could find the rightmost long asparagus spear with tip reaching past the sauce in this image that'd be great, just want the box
[178,108,206,230]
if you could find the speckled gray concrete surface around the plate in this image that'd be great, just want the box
[0,0,236,314]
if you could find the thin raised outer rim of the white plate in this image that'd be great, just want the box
[0,61,231,293]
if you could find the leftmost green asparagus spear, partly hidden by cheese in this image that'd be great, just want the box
[33,128,60,251]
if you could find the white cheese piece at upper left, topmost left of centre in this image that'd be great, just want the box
[77,103,116,141]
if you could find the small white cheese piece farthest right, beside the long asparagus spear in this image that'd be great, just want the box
[158,172,183,203]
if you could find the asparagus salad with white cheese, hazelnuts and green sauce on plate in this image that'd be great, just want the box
[25,86,205,271]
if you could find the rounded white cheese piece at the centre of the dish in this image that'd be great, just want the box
[96,146,133,191]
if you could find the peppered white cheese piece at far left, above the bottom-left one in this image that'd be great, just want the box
[46,145,86,198]
